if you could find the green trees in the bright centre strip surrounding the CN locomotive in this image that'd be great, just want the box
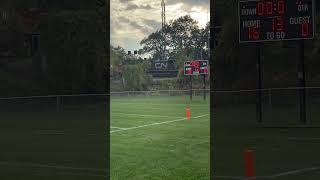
[110,15,210,90]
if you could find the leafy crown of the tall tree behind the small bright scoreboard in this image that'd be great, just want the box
[140,15,209,61]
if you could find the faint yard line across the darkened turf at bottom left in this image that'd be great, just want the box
[0,162,105,172]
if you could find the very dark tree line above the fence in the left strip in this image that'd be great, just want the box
[0,0,109,96]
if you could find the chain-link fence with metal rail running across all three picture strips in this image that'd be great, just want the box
[0,87,320,126]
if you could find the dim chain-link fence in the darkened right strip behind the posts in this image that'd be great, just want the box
[213,87,320,127]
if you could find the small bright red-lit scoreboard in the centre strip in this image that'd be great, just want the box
[184,60,208,76]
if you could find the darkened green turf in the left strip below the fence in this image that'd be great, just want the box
[0,106,106,180]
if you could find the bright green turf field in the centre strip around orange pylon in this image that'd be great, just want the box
[110,96,210,180]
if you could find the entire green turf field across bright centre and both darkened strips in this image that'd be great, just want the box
[0,93,320,180]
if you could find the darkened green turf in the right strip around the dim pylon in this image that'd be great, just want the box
[213,105,320,180]
